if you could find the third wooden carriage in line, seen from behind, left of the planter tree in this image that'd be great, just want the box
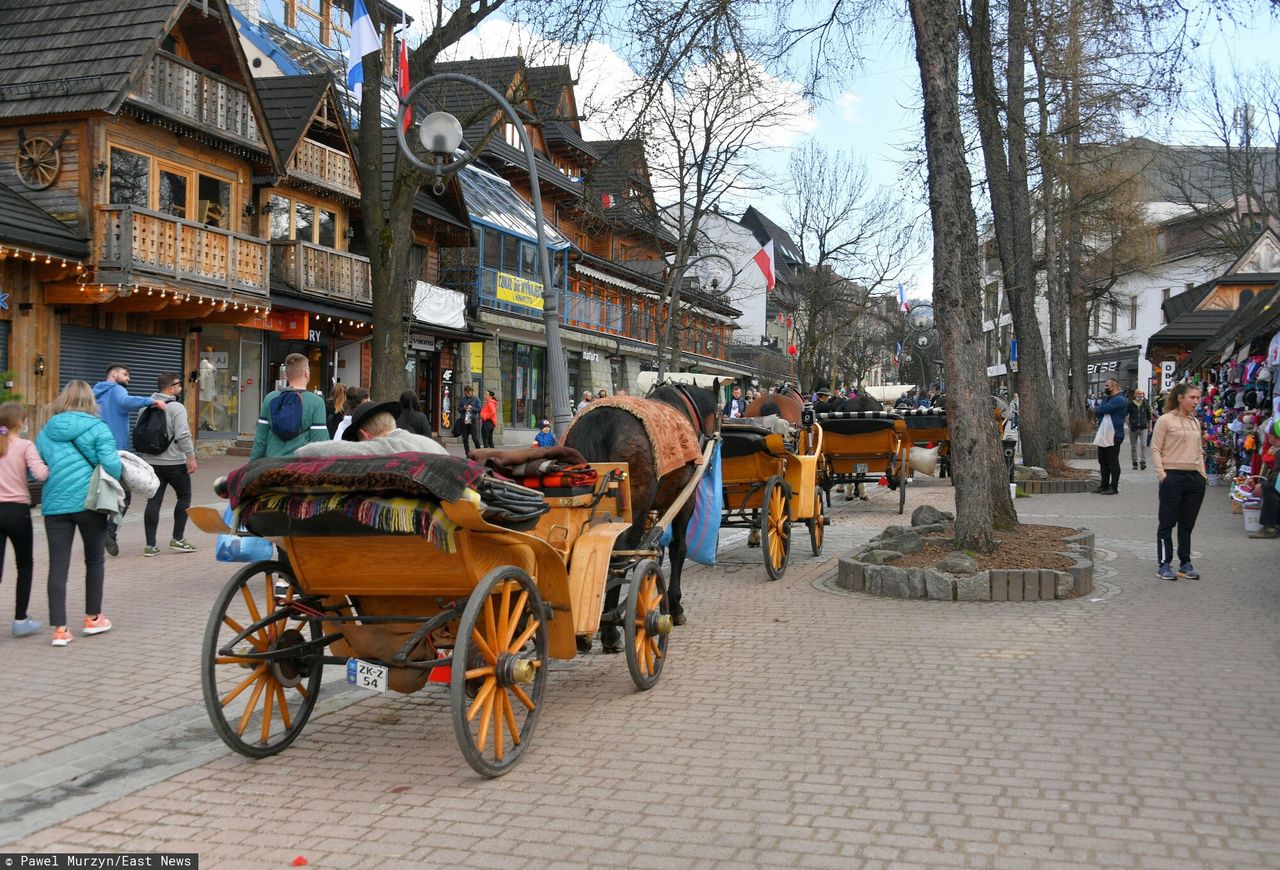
[818,411,911,513]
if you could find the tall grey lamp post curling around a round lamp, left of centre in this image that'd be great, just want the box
[396,73,573,438]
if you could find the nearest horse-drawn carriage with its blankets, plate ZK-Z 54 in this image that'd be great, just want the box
[189,383,716,777]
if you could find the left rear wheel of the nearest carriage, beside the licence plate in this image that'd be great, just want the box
[201,562,324,759]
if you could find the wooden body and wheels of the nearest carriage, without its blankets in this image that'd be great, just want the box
[191,447,710,777]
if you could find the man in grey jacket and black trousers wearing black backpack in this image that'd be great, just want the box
[133,371,196,557]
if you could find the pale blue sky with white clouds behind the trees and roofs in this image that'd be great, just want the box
[406,0,1280,298]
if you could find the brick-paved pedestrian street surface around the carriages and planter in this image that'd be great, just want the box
[0,459,1280,867]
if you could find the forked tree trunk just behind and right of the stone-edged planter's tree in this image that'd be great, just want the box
[969,0,1062,467]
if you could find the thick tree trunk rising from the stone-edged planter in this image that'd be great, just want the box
[909,0,1018,553]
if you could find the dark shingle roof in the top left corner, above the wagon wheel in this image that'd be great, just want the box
[0,0,186,118]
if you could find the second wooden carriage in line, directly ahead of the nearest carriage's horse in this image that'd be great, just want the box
[721,411,827,580]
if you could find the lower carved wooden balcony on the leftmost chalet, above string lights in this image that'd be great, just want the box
[93,206,271,298]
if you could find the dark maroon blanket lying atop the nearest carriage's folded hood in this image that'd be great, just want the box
[227,453,484,508]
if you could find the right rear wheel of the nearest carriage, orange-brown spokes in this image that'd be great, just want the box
[449,566,547,777]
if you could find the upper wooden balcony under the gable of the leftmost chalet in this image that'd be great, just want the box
[129,51,265,148]
